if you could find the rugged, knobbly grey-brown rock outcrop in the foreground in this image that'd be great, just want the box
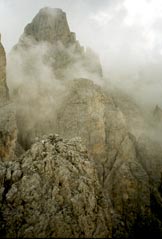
[0,135,111,238]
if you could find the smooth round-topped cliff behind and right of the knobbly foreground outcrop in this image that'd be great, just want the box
[56,79,153,238]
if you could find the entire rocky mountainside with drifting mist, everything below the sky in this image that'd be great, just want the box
[0,7,162,238]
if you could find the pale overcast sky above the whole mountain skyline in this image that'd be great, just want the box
[0,0,162,106]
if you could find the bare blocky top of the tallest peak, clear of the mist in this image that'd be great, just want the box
[24,7,75,46]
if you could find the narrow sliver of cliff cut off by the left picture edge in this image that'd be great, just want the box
[0,37,17,160]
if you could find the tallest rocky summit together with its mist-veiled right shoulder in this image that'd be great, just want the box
[14,7,102,80]
